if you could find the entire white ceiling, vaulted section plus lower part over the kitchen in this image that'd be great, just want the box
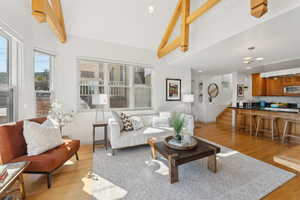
[62,0,300,73]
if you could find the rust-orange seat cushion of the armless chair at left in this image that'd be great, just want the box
[11,140,80,172]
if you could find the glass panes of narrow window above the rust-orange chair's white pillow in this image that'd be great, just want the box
[34,51,54,117]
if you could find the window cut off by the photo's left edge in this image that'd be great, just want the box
[0,31,14,124]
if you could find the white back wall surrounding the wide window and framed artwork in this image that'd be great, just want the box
[54,36,191,143]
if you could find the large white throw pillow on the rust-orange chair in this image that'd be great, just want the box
[23,120,63,156]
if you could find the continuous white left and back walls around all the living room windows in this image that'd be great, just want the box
[0,0,191,143]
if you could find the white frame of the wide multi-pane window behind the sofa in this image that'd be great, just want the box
[76,57,153,112]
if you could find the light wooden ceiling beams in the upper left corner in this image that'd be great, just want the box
[32,0,67,43]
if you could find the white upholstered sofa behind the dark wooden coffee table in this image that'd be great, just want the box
[108,112,194,153]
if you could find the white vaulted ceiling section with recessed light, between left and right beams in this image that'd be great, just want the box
[62,0,182,51]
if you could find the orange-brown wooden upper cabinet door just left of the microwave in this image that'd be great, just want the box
[266,77,283,96]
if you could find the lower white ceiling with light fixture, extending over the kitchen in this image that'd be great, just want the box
[172,7,300,74]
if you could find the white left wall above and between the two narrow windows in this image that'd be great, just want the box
[0,0,57,119]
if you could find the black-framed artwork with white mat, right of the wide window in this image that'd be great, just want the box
[166,79,181,101]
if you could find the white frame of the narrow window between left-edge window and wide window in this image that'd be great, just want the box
[33,48,56,115]
